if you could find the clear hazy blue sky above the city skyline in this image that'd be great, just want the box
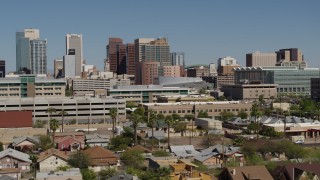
[0,0,320,70]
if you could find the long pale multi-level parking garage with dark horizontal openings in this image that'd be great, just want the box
[0,97,126,124]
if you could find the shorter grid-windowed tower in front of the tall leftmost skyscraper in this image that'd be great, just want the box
[30,39,47,74]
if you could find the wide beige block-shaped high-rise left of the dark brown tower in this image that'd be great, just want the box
[246,51,277,67]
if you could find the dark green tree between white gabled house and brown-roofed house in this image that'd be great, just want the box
[68,151,90,169]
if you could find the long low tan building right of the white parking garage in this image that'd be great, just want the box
[142,101,252,119]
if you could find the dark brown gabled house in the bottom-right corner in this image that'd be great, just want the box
[272,163,320,180]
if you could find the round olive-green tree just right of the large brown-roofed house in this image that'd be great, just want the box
[120,150,144,168]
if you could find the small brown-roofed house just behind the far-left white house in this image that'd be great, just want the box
[8,136,39,152]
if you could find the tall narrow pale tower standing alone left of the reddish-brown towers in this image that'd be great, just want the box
[66,34,83,76]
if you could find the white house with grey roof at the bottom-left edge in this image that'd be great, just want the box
[0,148,31,172]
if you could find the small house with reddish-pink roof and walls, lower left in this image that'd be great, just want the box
[54,132,84,151]
